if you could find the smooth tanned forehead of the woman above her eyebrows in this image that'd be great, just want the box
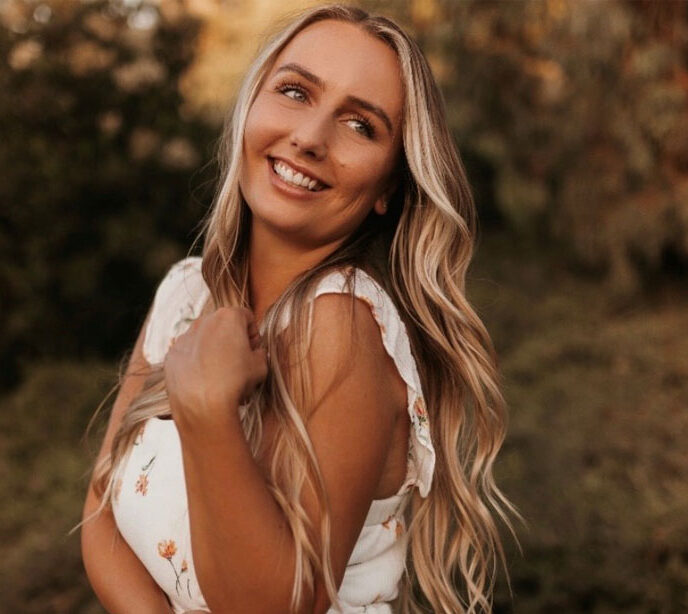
[271,19,403,124]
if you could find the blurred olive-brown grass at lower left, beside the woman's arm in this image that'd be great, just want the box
[0,361,117,614]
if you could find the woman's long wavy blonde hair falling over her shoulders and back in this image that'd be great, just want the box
[79,4,521,614]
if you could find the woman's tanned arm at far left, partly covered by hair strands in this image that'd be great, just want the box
[81,312,172,614]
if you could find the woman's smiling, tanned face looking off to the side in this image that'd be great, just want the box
[240,20,403,249]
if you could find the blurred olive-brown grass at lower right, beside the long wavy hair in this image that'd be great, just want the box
[468,235,688,614]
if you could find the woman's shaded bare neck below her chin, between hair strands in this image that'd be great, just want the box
[249,218,339,324]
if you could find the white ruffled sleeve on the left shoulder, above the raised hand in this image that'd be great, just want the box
[143,256,209,364]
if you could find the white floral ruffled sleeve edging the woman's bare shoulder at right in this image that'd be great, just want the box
[313,268,435,497]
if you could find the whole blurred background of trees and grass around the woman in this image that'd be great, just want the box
[0,0,688,614]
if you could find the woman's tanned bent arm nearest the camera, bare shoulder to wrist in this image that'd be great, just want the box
[165,295,405,614]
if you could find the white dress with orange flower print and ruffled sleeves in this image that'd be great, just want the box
[113,257,435,614]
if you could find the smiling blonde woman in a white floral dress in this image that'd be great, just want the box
[82,5,518,614]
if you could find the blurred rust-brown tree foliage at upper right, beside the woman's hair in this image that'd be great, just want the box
[376,0,688,296]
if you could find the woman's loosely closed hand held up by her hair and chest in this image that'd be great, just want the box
[163,307,268,426]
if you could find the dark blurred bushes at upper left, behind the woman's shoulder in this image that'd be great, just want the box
[0,1,217,385]
